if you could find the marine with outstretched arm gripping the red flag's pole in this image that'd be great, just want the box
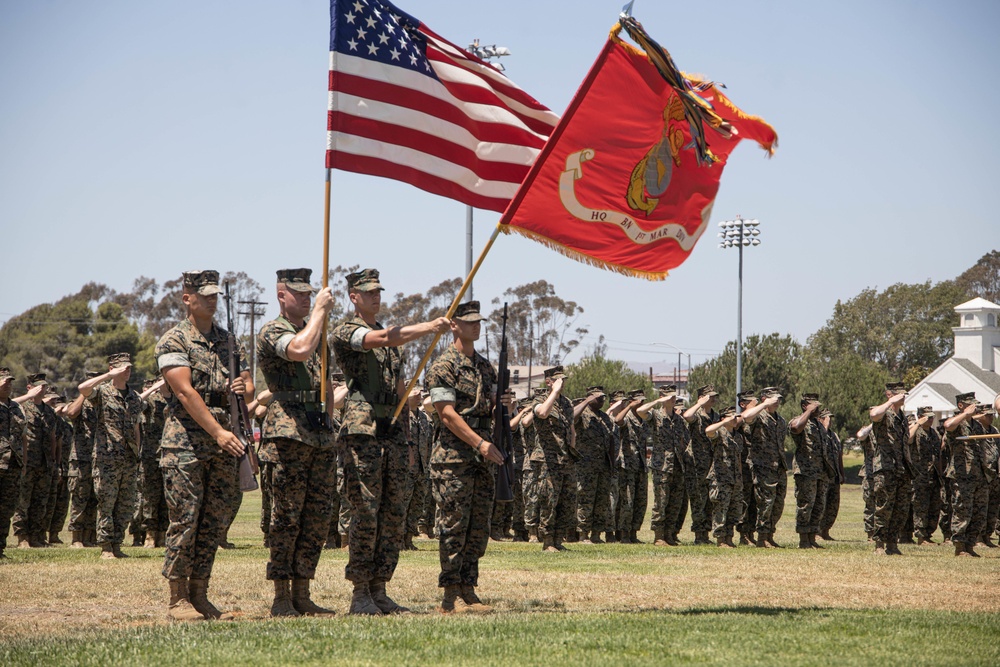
[333,269,449,614]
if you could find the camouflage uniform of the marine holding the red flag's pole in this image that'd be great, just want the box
[333,315,409,583]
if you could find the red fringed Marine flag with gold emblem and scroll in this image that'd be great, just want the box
[500,15,778,280]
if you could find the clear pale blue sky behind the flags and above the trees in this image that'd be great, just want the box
[0,0,1000,374]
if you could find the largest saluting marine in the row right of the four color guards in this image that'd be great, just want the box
[531,366,576,551]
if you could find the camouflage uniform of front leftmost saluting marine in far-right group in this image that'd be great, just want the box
[872,409,912,544]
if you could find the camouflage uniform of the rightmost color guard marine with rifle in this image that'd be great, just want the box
[425,345,497,588]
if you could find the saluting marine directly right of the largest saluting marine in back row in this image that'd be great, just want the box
[574,385,616,544]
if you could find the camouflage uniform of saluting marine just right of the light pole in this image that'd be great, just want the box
[747,410,788,535]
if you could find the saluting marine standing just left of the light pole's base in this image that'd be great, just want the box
[705,406,743,548]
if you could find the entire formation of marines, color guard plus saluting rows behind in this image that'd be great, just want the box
[0,269,1000,621]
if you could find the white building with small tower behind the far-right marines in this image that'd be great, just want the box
[903,297,1000,418]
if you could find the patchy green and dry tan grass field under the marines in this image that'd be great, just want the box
[0,468,1000,665]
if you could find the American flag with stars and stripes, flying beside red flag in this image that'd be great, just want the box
[326,0,559,212]
